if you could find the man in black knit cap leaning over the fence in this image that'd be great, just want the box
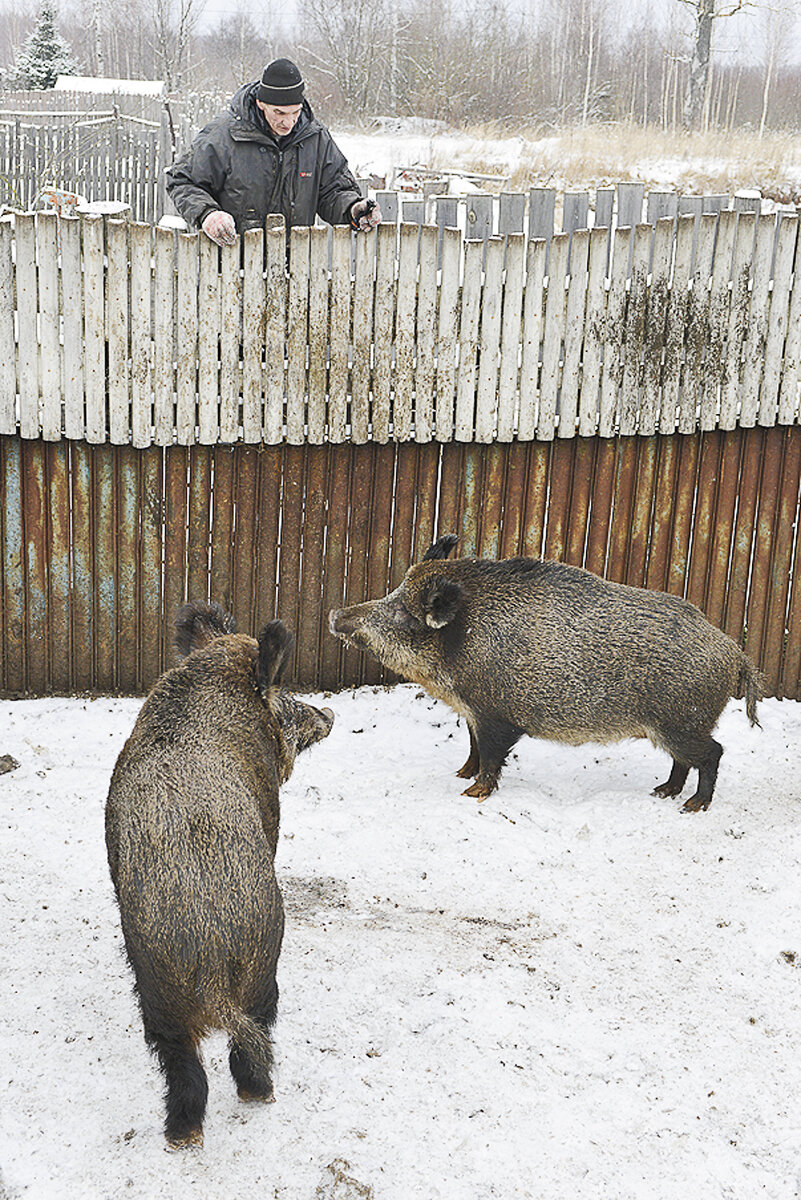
[167,59,381,246]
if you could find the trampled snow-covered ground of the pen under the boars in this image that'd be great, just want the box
[0,685,801,1200]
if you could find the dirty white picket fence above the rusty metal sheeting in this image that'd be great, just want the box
[0,210,801,446]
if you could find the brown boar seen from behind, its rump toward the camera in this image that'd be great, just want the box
[106,605,333,1146]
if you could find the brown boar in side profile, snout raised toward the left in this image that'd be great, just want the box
[329,534,760,812]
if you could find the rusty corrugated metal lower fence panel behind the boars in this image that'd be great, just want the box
[0,425,801,698]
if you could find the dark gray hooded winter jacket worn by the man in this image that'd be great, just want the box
[165,82,361,233]
